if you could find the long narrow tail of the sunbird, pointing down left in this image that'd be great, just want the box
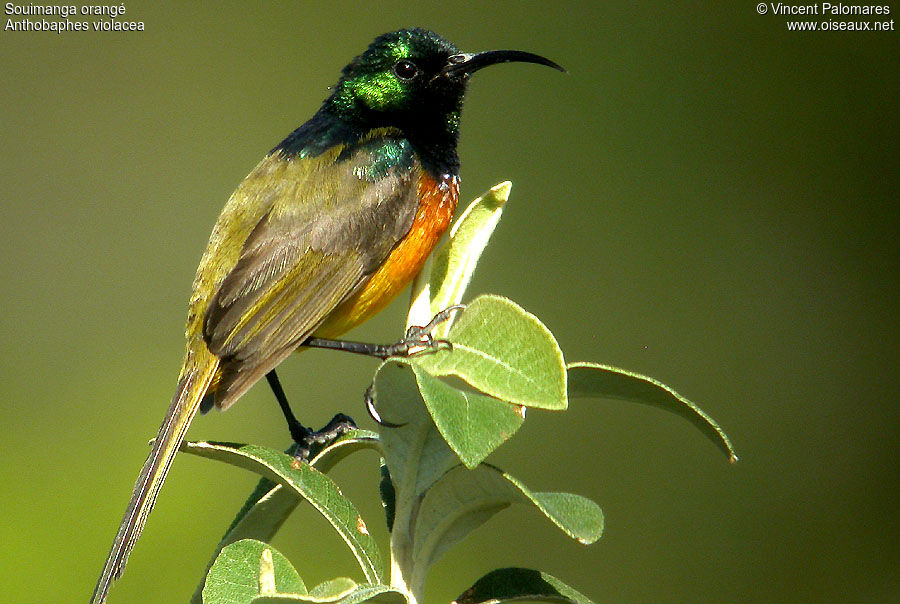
[91,349,218,604]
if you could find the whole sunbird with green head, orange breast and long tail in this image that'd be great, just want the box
[91,28,564,604]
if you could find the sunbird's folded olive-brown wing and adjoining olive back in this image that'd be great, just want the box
[203,150,418,408]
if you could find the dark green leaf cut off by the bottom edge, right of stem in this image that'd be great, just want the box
[453,568,593,604]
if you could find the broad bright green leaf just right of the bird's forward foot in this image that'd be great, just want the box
[410,296,568,410]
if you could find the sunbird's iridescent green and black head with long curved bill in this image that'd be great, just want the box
[325,28,562,150]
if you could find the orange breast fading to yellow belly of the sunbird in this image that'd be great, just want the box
[313,171,459,338]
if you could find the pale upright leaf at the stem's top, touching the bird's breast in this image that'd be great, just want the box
[407,181,512,338]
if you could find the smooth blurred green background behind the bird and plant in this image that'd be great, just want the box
[0,1,900,604]
